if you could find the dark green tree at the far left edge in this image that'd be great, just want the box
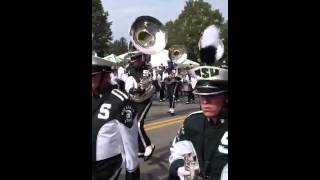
[92,0,112,57]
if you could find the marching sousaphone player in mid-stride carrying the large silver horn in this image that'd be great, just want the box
[125,16,167,161]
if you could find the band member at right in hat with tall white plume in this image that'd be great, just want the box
[169,25,228,180]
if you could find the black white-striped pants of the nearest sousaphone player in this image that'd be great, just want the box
[136,99,152,153]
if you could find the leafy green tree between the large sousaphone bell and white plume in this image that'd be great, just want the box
[165,0,224,61]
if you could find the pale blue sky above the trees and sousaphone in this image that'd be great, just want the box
[101,0,228,40]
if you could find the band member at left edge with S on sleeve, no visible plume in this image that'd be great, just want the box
[92,57,140,180]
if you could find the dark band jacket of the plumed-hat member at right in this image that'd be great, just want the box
[169,111,228,180]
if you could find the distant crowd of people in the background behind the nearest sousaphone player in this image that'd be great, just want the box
[111,64,196,115]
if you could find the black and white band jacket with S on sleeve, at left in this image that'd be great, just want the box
[92,89,139,177]
